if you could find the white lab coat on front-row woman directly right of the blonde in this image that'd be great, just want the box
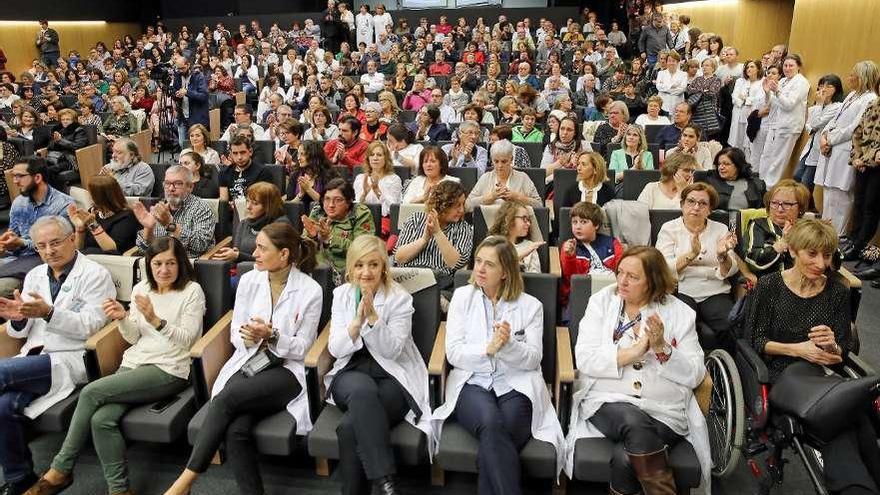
[434,284,565,474]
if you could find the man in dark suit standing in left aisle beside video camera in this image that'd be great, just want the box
[171,56,210,148]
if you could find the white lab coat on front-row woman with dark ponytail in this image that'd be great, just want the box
[211,267,324,435]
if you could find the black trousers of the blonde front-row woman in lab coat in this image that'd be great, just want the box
[330,353,410,495]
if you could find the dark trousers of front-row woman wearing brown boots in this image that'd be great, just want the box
[590,402,682,494]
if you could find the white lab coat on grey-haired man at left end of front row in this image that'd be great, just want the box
[6,253,116,419]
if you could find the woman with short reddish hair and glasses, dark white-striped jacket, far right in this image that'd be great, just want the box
[743,179,808,278]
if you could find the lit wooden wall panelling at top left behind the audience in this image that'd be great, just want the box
[0,22,141,74]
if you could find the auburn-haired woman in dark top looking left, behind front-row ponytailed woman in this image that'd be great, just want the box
[211,182,290,263]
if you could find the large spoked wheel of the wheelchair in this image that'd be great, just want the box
[706,349,745,479]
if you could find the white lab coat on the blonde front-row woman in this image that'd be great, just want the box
[324,282,437,456]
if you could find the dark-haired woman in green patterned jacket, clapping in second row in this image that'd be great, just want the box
[302,178,376,285]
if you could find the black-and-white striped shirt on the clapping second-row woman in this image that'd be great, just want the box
[395,211,474,275]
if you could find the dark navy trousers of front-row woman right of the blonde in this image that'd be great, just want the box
[455,384,532,495]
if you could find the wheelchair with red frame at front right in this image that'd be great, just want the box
[698,296,880,495]
